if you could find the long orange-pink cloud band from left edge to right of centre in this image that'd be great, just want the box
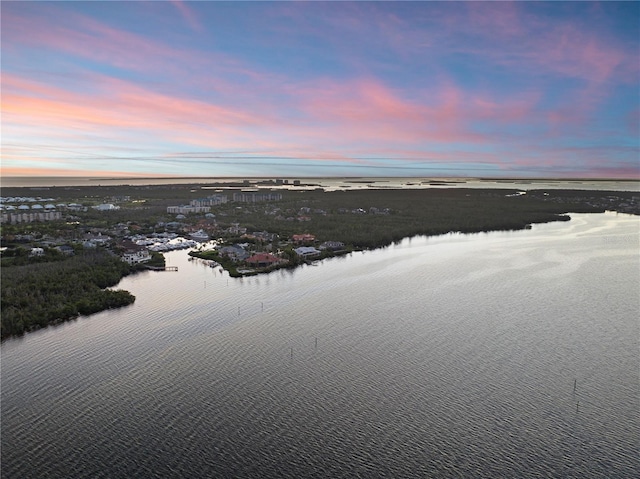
[2,68,535,164]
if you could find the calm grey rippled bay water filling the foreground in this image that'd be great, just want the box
[2,213,640,478]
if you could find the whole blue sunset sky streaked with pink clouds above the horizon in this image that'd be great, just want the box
[0,0,640,179]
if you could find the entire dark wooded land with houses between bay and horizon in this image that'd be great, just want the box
[0,182,640,346]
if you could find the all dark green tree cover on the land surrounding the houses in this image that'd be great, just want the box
[0,185,634,338]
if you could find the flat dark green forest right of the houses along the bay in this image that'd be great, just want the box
[221,189,601,248]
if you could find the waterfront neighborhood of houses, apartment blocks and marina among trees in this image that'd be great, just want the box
[0,187,356,275]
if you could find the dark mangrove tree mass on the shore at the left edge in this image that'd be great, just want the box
[0,250,135,339]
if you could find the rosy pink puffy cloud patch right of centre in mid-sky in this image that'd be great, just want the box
[294,78,539,145]
